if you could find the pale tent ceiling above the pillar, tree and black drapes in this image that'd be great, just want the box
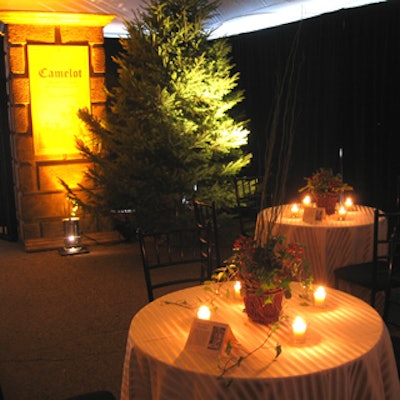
[0,0,385,37]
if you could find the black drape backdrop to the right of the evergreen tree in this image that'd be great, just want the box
[229,2,400,209]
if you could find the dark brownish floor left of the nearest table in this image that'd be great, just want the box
[0,219,400,400]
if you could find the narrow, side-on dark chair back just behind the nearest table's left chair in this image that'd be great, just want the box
[193,199,221,269]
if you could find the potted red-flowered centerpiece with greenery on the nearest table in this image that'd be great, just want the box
[214,236,312,325]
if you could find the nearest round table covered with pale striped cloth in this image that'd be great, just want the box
[121,283,400,400]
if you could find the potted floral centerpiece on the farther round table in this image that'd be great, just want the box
[299,168,353,215]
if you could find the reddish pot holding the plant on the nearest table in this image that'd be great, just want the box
[243,289,283,325]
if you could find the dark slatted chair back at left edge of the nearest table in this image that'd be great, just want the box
[137,228,211,301]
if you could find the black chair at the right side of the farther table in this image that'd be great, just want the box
[334,209,400,319]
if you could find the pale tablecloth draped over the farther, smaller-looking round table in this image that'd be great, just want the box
[255,205,385,286]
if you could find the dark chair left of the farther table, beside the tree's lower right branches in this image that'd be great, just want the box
[234,176,262,236]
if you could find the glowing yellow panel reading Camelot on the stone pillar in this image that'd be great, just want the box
[28,45,90,158]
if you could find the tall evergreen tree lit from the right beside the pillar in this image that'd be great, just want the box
[69,0,251,233]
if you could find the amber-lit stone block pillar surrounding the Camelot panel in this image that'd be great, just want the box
[0,13,112,242]
